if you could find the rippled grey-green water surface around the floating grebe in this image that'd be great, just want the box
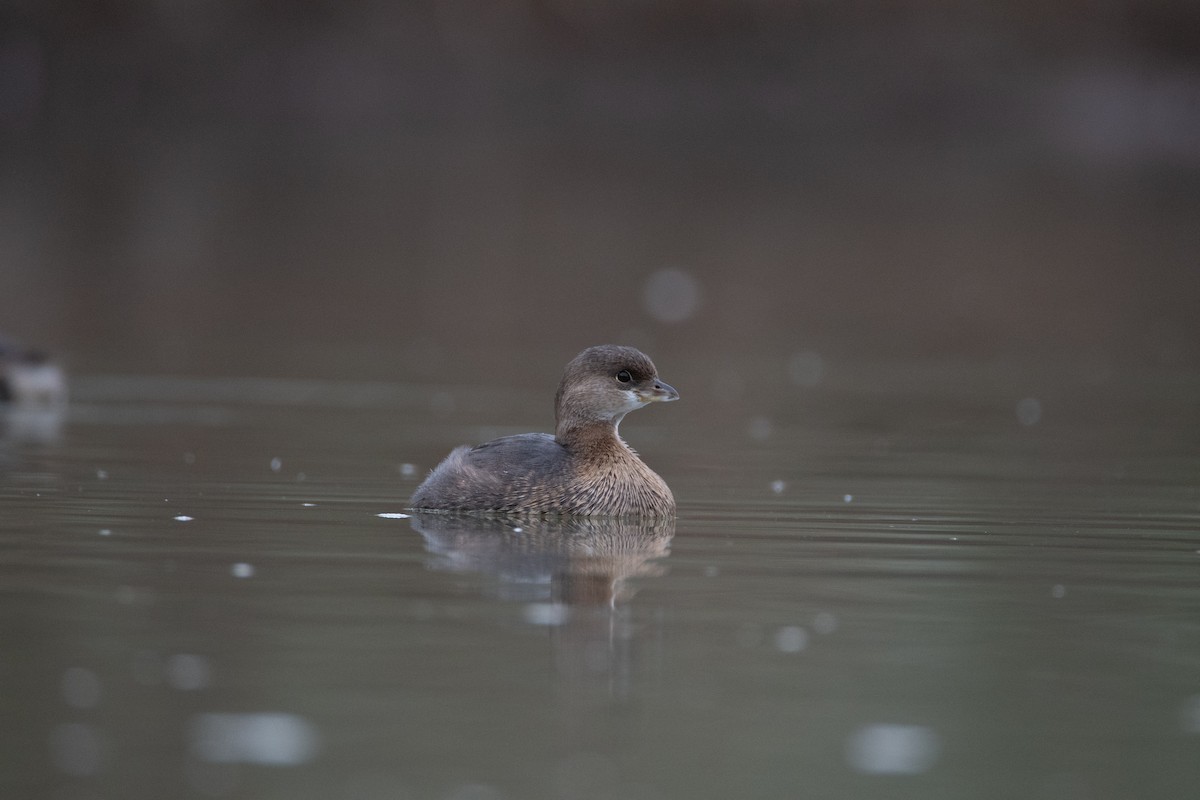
[0,360,1200,800]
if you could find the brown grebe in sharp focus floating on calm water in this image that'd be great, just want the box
[412,344,679,517]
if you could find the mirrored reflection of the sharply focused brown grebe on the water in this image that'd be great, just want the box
[412,512,674,608]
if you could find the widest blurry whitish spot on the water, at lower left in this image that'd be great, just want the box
[188,712,320,766]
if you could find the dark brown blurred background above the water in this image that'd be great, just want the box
[0,0,1200,385]
